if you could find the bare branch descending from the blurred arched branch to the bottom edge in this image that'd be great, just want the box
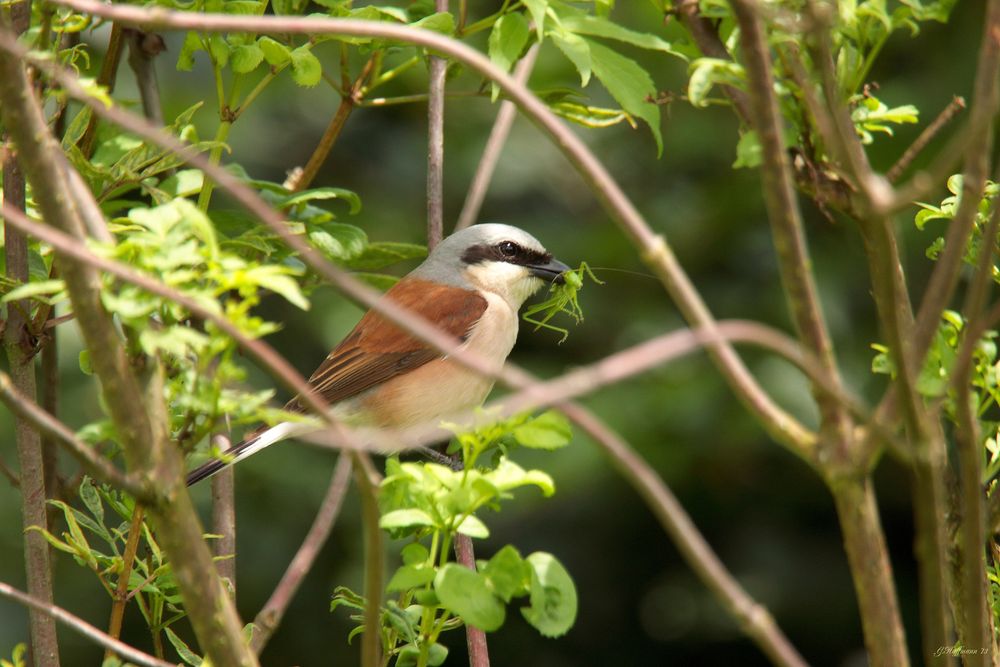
[559,403,806,667]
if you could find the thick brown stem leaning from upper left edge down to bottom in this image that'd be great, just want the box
[0,28,256,667]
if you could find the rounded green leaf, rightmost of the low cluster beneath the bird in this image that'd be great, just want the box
[521,551,577,637]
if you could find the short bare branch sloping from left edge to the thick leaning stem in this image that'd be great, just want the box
[0,372,152,501]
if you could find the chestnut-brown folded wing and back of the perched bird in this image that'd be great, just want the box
[287,279,487,411]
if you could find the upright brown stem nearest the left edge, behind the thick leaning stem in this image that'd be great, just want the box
[0,122,59,666]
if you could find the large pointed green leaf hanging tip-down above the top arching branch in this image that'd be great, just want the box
[587,40,663,156]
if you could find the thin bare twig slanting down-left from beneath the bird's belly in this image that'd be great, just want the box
[250,455,351,655]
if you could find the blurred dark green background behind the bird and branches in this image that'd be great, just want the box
[0,1,983,667]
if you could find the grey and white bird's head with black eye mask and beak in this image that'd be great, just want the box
[413,224,569,308]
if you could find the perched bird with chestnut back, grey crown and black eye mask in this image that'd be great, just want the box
[187,223,569,486]
